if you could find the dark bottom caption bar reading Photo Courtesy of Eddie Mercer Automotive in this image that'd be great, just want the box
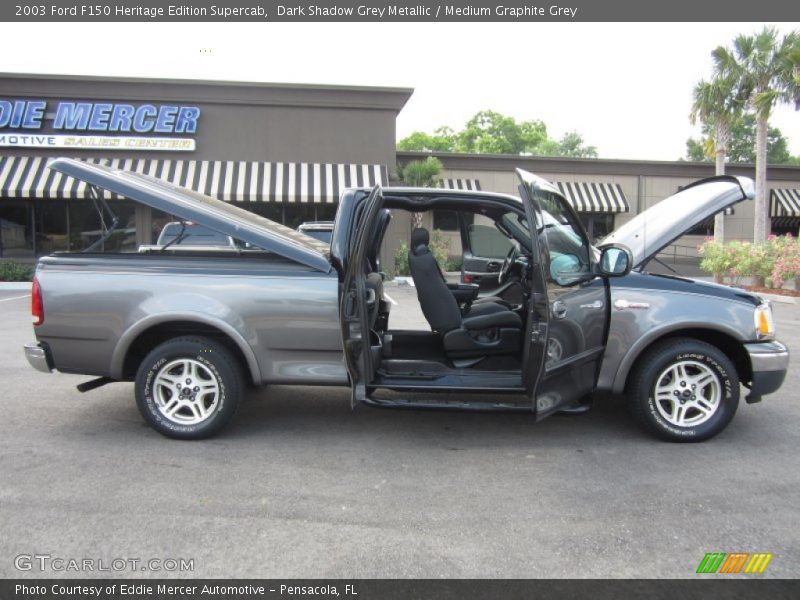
[0,576,800,600]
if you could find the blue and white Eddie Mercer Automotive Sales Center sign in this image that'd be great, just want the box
[0,98,200,152]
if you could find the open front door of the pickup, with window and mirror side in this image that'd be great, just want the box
[517,170,609,419]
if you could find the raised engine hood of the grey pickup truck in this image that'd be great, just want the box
[597,175,755,268]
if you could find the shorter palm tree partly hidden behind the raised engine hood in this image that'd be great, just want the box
[689,76,742,242]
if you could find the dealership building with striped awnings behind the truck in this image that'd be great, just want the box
[0,74,800,272]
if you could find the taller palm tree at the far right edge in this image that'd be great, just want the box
[712,27,800,242]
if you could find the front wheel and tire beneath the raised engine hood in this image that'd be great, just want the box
[628,338,739,442]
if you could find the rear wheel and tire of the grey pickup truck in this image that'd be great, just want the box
[135,336,244,440]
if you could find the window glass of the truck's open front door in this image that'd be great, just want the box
[534,190,591,287]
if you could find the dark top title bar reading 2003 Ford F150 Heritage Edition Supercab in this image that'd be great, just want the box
[0,0,798,21]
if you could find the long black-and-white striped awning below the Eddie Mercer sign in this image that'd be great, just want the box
[0,156,389,204]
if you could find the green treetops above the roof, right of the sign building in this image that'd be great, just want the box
[397,110,597,158]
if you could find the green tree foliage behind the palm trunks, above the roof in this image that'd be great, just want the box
[686,113,800,165]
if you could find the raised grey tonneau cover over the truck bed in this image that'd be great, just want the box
[48,158,331,273]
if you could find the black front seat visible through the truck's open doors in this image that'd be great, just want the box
[408,228,522,358]
